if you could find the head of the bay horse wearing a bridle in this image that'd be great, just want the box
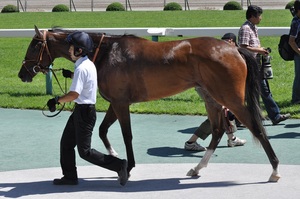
[18,26,53,82]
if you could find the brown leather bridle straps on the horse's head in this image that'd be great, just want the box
[22,30,53,77]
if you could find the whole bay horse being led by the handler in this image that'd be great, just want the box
[18,26,280,182]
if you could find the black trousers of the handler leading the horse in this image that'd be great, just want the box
[60,104,122,179]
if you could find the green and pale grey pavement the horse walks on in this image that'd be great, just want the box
[0,108,300,199]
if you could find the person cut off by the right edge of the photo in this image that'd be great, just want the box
[289,0,300,104]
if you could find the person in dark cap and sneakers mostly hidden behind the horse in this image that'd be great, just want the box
[184,33,247,151]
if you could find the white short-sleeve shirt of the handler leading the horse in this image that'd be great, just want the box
[70,56,97,104]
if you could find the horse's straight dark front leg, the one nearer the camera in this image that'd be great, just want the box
[111,102,135,174]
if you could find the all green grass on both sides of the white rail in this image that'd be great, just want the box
[0,10,300,118]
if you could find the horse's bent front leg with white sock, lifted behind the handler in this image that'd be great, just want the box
[99,105,118,157]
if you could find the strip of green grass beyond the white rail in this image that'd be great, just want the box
[0,10,292,29]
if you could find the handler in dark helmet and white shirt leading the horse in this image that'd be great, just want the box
[47,32,128,186]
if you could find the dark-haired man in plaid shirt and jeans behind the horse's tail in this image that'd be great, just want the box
[238,5,290,125]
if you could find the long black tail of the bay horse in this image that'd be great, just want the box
[238,48,266,138]
